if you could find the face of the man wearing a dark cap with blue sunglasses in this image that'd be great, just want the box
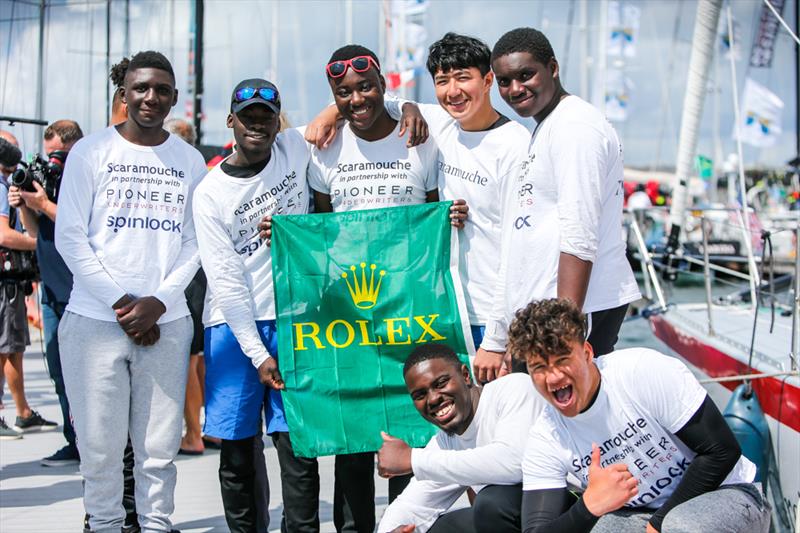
[228,104,280,163]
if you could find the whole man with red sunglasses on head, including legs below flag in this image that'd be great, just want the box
[266,45,444,533]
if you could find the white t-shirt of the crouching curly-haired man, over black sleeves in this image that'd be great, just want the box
[522,348,756,509]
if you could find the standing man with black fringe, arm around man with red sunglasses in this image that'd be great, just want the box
[306,33,530,382]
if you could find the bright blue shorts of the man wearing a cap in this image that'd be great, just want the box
[203,320,289,440]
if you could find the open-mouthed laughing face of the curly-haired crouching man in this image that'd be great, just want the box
[527,341,600,417]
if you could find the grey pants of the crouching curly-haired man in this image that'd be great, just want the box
[592,483,770,533]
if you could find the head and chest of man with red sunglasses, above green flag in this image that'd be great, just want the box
[308,45,439,213]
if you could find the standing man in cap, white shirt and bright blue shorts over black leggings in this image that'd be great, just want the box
[194,79,310,533]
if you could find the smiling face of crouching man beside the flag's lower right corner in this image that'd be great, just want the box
[405,358,475,435]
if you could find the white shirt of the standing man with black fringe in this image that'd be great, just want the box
[386,99,530,325]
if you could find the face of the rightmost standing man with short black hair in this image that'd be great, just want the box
[492,52,562,122]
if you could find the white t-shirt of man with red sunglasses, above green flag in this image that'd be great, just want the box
[308,123,436,213]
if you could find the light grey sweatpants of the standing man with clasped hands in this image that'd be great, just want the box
[58,312,192,533]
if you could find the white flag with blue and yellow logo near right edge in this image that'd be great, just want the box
[733,78,783,148]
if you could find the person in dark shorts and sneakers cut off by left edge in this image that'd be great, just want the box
[0,132,56,439]
